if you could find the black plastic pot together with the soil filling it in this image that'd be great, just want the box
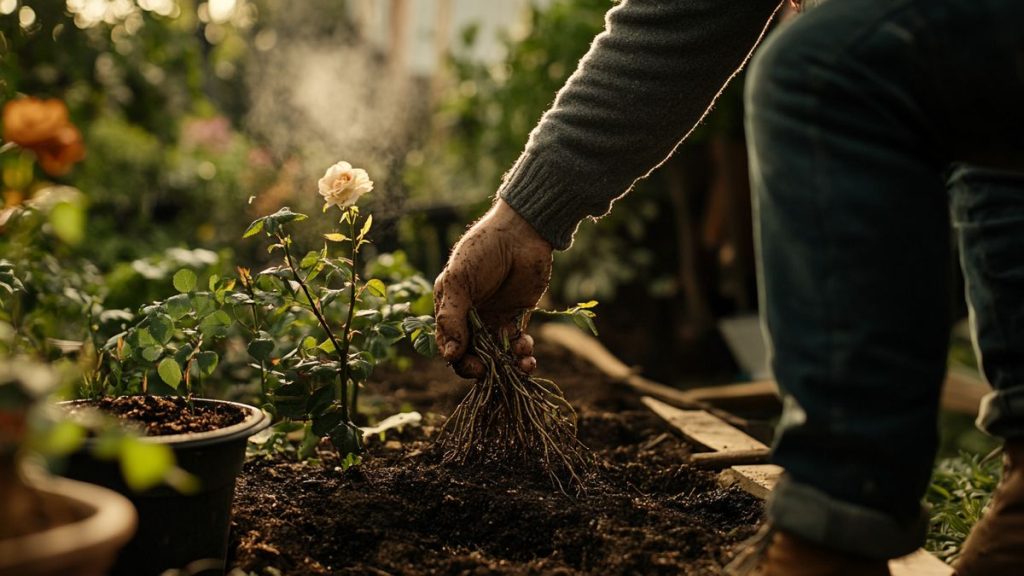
[62,396,270,576]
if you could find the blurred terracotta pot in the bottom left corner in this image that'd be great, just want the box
[0,476,135,576]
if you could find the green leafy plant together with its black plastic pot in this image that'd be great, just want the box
[55,276,270,576]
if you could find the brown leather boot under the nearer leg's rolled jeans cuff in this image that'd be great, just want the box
[726,532,891,576]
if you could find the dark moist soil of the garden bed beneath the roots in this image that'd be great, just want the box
[230,338,762,575]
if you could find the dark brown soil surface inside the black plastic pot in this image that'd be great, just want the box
[72,396,246,436]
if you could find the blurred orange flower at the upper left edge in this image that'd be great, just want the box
[3,97,85,176]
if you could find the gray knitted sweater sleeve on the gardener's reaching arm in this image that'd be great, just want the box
[498,0,779,250]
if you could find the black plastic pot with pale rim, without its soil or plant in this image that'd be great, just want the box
[62,399,270,576]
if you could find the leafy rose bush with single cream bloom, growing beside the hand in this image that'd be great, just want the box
[234,162,436,463]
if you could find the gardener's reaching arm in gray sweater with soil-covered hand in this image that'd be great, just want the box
[435,0,779,375]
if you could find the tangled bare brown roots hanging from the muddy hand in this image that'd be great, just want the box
[438,312,590,494]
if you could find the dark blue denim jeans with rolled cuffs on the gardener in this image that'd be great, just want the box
[746,0,1024,559]
